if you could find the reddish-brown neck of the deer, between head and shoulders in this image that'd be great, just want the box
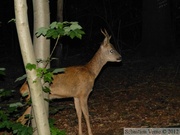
[86,49,107,78]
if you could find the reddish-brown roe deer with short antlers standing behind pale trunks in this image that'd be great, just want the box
[18,30,121,135]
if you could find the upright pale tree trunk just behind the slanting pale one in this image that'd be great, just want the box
[31,0,50,135]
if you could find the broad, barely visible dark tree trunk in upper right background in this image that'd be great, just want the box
[142,0,173,56]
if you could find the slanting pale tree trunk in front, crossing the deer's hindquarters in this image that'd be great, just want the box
[14,0,50,135]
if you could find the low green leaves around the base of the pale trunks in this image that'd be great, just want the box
[0,88,66,135]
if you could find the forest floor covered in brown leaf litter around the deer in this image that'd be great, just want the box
[0,53,180,135]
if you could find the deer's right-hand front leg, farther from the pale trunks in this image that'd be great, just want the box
[80,97,93,135]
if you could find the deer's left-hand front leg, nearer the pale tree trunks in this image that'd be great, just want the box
[74,98,82,135]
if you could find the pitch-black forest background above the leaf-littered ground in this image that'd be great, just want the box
[0,0,180,87]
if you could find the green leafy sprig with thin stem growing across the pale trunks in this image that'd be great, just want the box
[22,21,85,83]
